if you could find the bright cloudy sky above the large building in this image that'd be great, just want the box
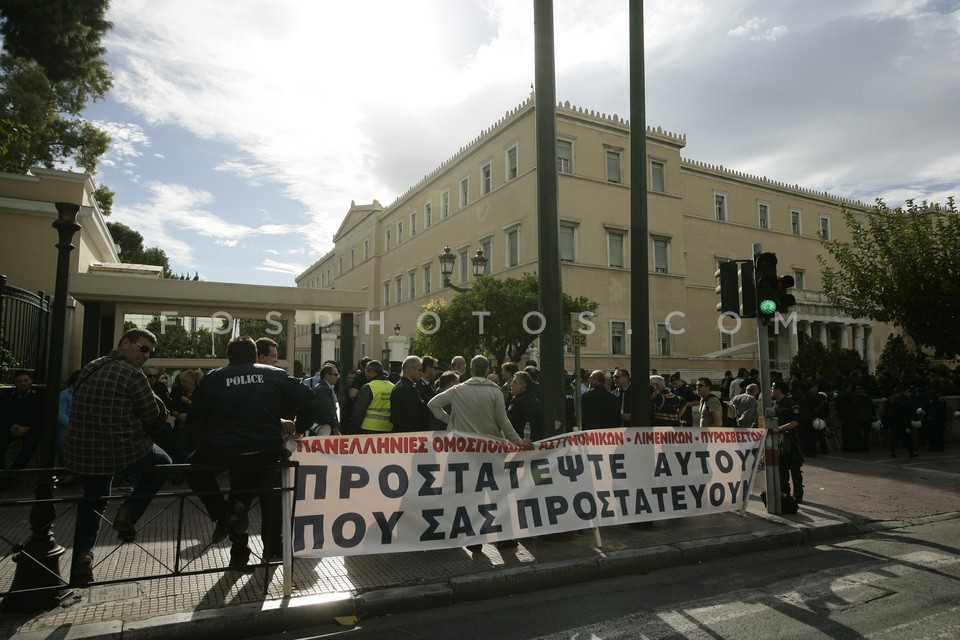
[86,0,960,286]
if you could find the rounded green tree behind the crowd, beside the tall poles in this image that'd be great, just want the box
[413,273,599,362]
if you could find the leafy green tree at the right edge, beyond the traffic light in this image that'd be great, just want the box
[817,197,960,356]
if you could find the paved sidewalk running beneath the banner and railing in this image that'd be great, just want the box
[0,448,960,640]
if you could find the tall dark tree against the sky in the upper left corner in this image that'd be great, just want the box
[0,0,112,173]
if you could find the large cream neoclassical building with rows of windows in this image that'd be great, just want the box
[296,96,889,376]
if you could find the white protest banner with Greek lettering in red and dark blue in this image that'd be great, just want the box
[293,427,766,557]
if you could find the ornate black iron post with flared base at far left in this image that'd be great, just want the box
[3,202,80,611]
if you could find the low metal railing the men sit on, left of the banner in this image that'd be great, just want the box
[0,460,297,610]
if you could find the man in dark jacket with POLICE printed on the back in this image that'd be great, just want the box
[187,337,321,570]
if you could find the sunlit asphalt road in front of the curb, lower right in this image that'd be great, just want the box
[269,520,960,640]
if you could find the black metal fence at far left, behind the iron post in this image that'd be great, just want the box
[0,275,52,383]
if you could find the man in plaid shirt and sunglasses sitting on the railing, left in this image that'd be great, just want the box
[66,329,170,585]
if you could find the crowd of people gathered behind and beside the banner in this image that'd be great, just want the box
[0,342,960,585]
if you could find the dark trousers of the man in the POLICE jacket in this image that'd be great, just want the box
[187,449,280,559]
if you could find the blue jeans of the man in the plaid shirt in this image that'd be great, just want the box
[73,445,170,556]
